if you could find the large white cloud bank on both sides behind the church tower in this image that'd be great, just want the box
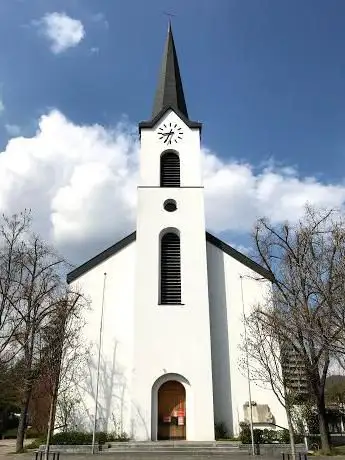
[0,110,345,262]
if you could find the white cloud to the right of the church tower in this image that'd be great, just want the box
[203,151,345,235]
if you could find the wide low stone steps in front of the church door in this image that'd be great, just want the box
[102,441,242,454]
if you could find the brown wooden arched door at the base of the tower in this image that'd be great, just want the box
[157,380,186,440]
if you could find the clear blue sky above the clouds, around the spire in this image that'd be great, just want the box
[0,0,345,262]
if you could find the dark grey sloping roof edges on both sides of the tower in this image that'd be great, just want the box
[67,232,274,284]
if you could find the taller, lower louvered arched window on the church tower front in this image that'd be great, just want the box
[160,233,181,305]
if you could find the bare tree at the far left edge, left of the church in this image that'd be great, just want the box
[0,211,73,452]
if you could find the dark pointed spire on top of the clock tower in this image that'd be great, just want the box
[152,21,188,120]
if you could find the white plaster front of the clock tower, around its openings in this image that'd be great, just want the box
[133,112,214,441]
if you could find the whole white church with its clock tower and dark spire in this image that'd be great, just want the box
[67,26,287,441]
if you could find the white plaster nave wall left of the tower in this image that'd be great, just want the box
[64,242,136,434]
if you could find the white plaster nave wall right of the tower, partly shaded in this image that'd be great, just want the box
[207,243,287,436]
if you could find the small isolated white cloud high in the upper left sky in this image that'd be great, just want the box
[34,12,85,54]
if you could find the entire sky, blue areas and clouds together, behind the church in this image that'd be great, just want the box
[0,0,345,264]
